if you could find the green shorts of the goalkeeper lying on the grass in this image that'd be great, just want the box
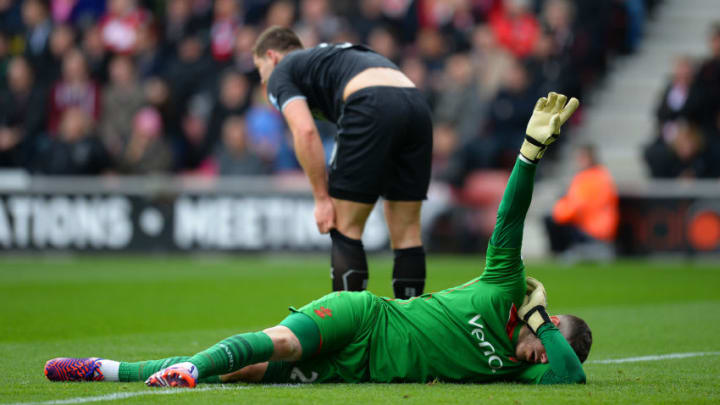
[263,291,382,383]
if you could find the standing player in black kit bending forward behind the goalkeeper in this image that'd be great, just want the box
[254,27,432,298]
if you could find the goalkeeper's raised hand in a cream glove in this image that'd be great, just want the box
[520,92,580,162]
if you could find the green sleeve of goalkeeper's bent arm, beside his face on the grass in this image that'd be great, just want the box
[538,323,585,384]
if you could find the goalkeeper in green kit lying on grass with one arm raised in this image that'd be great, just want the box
[45,93,592,387]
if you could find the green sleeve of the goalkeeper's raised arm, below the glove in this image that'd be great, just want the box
[482,158,535,293]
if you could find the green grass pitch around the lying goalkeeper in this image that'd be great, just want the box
[0,255,720,405]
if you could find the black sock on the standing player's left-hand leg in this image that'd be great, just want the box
[330,229,368,291]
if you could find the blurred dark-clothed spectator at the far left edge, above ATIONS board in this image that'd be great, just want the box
[0,56,45,167]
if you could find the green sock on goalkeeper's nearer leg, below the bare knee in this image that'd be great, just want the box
[186,332,274,378]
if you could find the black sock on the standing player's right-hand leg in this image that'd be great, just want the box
[393,246,425,299]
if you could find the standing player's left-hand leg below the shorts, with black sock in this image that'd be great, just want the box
[330,198,374,291]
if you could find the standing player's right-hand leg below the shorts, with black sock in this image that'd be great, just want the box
[384,200,426,299]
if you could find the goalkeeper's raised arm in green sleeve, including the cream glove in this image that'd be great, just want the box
[483,93,579,285]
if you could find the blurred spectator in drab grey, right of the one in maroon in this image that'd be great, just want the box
[99,55,145,158]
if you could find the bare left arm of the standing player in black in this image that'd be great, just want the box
[282,98,335,233]
